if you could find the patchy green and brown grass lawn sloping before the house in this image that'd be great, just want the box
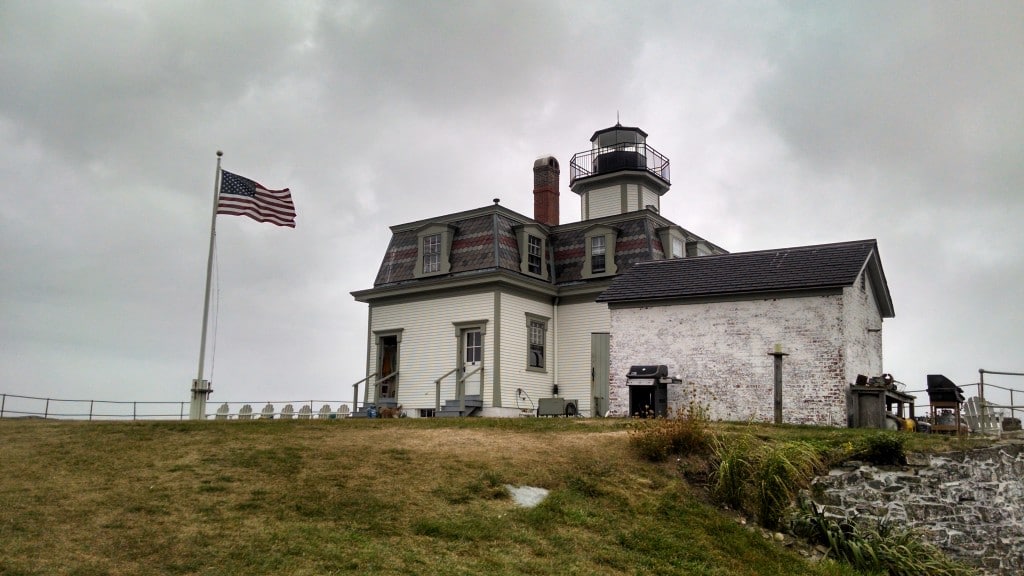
[0,418,974,576]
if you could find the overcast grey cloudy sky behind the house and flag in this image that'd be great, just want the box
[0,0,1024,412]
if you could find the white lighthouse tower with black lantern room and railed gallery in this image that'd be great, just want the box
[569,123,672,220]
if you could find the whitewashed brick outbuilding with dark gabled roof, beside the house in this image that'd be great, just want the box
[597,240,894,426]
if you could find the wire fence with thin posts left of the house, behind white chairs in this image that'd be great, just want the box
[0,394,353,420]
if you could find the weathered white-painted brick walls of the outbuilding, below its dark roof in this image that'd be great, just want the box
[609,284,882,426]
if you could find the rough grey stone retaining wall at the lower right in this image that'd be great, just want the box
[813,441,1024,576]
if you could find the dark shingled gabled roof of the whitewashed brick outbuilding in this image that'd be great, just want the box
[597,240,894,318]
